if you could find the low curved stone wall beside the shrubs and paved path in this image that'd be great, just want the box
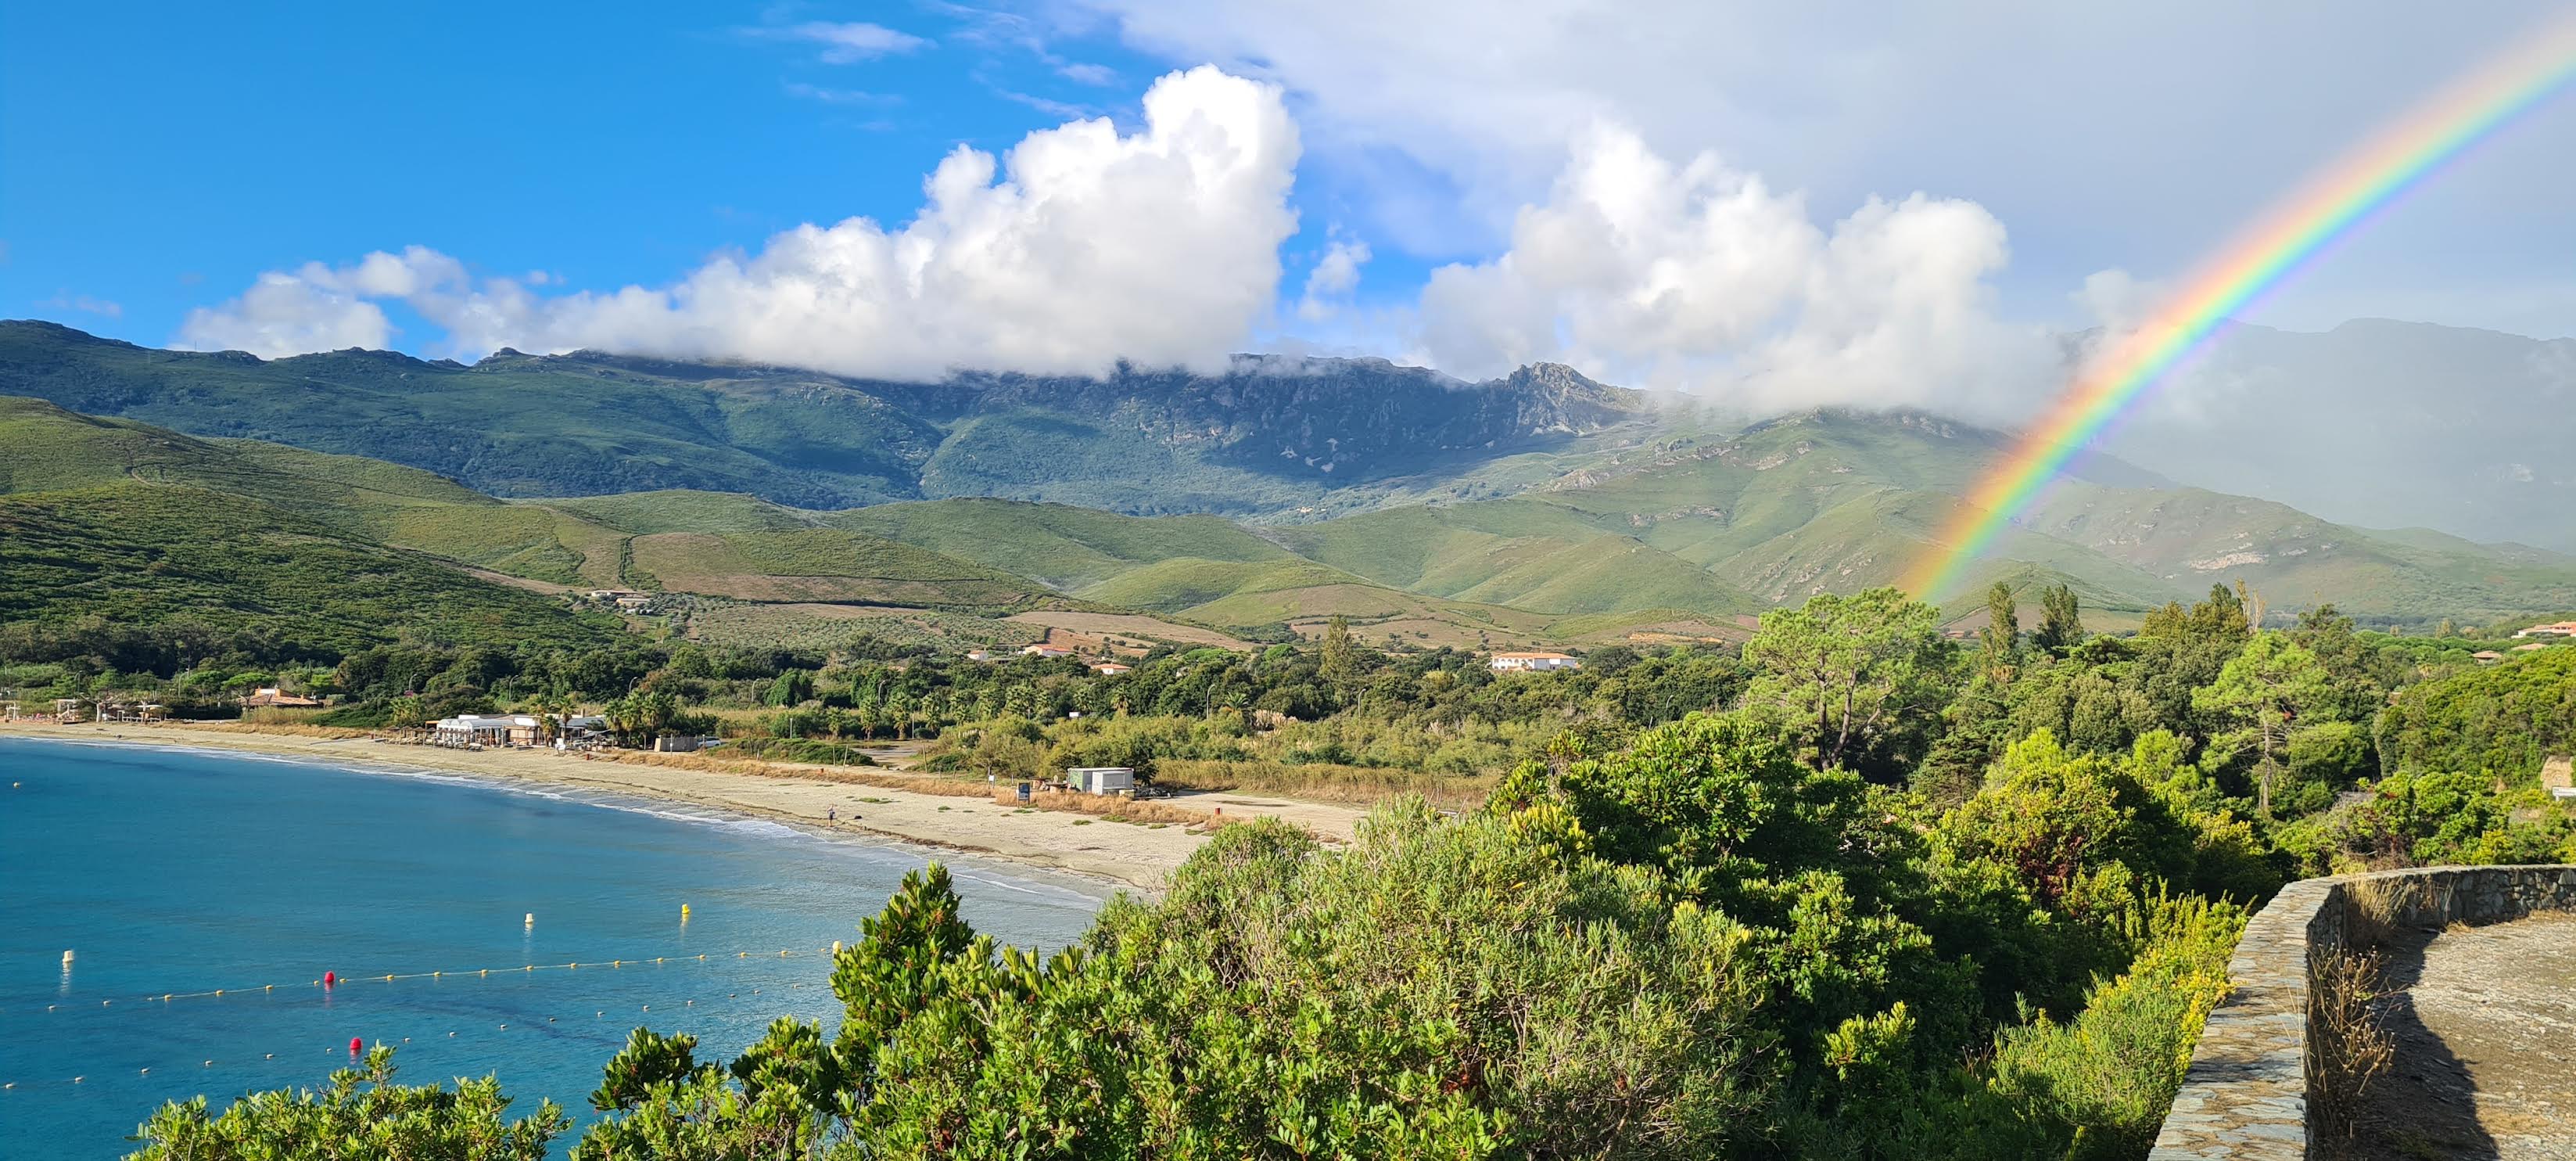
[2148,865,2576,1161]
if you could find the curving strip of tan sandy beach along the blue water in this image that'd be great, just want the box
[0,718,1365,891]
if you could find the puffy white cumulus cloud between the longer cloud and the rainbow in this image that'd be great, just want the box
[1414,124,2050,412]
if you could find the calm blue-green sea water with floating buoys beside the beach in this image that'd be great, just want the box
[0,739,1107,1159]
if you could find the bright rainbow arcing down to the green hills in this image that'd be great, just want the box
[1903,18,2576,597]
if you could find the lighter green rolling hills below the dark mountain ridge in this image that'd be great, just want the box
[0,370,2576,644]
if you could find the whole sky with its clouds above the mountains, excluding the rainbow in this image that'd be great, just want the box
[0,0,2576,409]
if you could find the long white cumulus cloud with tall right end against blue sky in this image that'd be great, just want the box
[181,67,1298,379]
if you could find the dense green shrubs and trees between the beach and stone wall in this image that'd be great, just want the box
[95,590,2576,1161]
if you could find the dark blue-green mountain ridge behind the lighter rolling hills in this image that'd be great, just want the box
[0,322,1646,515]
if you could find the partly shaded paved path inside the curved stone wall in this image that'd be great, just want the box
[2345,914,2576,1161]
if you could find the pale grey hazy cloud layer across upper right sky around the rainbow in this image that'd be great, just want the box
[1071,0,2576,335]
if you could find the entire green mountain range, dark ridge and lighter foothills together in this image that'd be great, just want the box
[0,325,2576,644]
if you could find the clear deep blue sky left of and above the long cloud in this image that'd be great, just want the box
[0,2,1432,345]
